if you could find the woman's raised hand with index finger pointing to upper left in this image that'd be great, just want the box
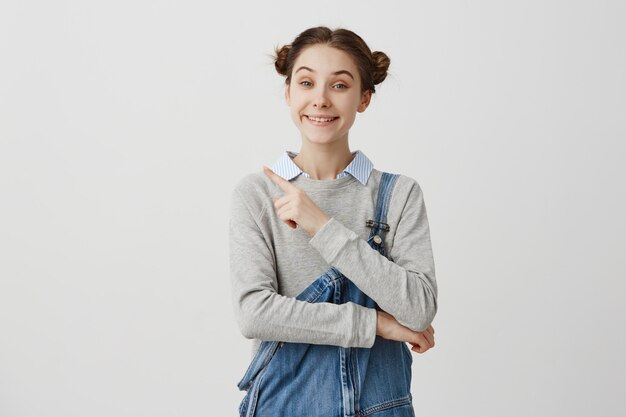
[263,166,330,237]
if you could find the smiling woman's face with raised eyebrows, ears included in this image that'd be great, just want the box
[285,44,371,144]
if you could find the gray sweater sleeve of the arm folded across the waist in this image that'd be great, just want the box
[229,188,377,347]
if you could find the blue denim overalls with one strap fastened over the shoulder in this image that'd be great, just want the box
[237,172,415,417]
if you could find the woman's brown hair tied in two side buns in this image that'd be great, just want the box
[272,26,391,93]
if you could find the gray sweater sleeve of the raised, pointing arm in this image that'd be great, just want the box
[309,180,437,332]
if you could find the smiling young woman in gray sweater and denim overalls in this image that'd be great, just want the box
[229,27,437,417]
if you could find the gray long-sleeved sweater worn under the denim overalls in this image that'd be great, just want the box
[229,169,437,357]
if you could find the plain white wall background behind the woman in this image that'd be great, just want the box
[0,0,626,417]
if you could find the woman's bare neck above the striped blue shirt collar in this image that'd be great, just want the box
[293,140,353,180]
